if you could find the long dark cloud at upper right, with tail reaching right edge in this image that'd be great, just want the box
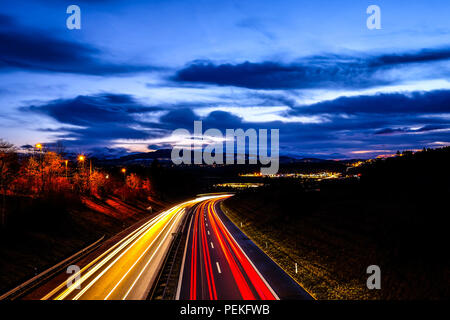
[172,48,450,89]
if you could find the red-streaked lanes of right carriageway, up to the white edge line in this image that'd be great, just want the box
[177,196,279,300]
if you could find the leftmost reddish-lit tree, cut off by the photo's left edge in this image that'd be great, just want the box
[0,139,18,226]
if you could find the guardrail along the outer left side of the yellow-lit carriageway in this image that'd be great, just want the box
[0,235,105,300]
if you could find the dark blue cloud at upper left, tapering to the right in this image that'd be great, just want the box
[0,15,158,75]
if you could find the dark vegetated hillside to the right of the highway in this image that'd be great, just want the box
[224,147,450,299]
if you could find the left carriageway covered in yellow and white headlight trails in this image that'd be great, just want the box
[41,197,221,300]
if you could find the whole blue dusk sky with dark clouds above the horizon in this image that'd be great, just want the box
[0,0,450,158]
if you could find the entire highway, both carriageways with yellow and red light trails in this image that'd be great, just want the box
[27,195,312,300]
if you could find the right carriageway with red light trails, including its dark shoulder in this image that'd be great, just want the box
[177,197,311,300]
